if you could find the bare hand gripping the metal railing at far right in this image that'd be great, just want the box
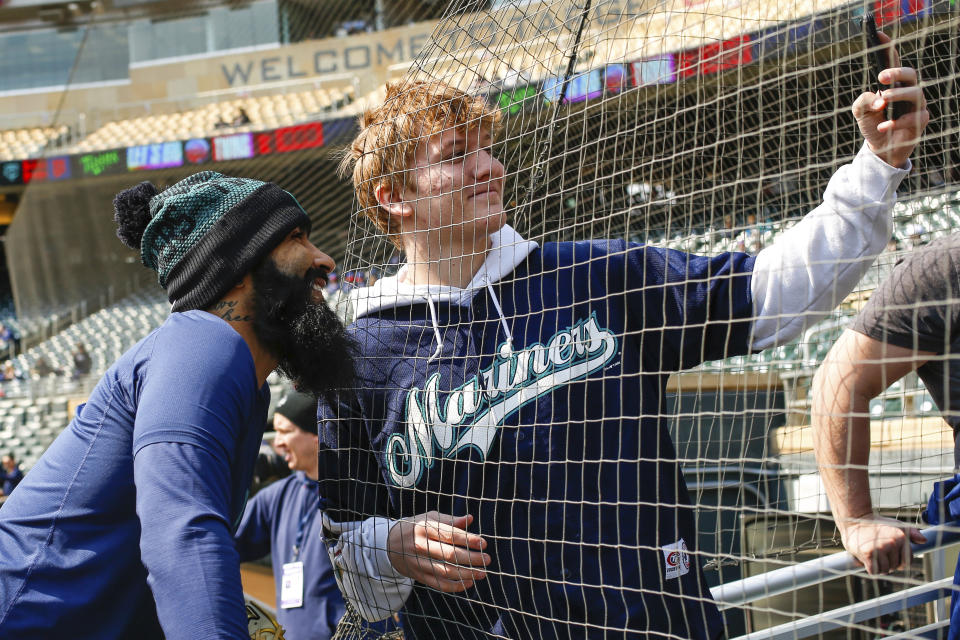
[840,514,927,574]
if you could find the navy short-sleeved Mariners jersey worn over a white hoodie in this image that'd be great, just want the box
[320,241,754,639]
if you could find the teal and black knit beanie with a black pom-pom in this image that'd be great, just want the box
[113,171,310,311]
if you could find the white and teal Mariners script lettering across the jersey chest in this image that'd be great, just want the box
[387,314,617,487]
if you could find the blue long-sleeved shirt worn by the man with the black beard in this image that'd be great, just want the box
[0,311,270,640]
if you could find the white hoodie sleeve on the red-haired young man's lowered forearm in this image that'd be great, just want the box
[322,514,413,622]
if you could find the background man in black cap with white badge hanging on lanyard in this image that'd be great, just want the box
[234,390,346,640]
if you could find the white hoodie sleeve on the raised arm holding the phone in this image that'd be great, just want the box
[750,144,911,350]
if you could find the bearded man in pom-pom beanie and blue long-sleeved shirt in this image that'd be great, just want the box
[0,171,354,640]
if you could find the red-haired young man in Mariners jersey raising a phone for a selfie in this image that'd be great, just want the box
[319,26,929,639]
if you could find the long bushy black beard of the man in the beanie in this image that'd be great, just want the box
[252,258,357,406]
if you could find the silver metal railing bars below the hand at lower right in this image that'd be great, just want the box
[710,524,960,640]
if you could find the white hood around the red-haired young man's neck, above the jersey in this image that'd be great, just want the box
[353,224,538,318]
